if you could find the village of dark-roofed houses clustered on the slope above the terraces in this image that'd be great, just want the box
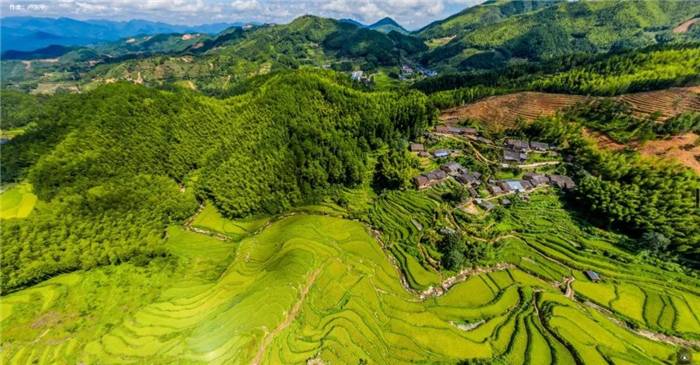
[409,125,576,212]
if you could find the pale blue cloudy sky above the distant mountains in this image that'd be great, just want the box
[0,0,483,29]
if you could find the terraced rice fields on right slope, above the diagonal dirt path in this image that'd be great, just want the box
[506,195,700,343]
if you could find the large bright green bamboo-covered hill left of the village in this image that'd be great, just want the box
[0,72,434,291]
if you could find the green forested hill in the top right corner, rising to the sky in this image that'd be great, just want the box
[419,0,700,70]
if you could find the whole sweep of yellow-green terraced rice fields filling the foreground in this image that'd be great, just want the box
[0,199,700,364]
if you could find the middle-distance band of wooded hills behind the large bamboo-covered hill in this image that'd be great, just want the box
[2,16,427,91]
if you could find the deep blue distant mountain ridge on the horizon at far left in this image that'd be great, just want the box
[0,17,243,52]
